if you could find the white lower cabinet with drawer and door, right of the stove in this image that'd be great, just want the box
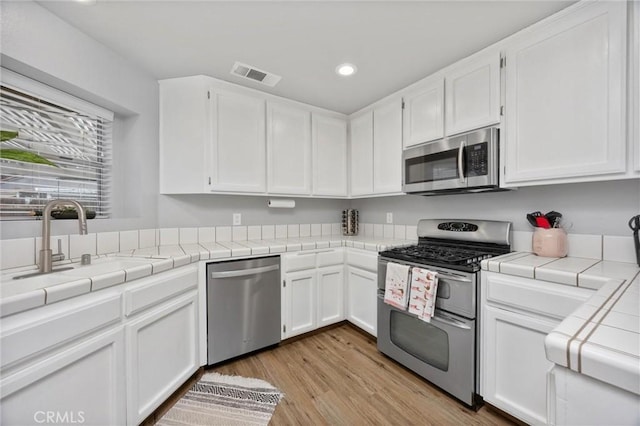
[480,271,593,425]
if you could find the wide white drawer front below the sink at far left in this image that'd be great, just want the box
[0,294,121,370]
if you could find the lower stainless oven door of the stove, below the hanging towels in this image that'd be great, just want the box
[378,292,476,407]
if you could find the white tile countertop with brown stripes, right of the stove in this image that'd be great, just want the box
[482,252,640,395]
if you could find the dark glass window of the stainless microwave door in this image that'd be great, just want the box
[405,149,458,184]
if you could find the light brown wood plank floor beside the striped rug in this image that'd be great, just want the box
[206,324,514,426]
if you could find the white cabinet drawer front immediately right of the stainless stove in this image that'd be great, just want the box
[483,273,594,320]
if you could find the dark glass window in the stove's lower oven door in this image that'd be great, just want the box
[389,310,449,371]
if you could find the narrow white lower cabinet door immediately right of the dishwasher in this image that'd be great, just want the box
[284,268,317,338]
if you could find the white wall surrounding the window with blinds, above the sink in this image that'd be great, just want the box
[0,1,158,239]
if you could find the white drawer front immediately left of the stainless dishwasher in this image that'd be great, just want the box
[124,265,198,316]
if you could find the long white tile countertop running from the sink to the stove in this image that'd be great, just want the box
[0,235,415,317]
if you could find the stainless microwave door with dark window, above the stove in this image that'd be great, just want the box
[402,138,467,193]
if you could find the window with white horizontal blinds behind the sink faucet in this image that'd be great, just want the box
[0,69,113,220]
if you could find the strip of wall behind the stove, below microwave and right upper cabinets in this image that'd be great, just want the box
[351,179,640,236]
